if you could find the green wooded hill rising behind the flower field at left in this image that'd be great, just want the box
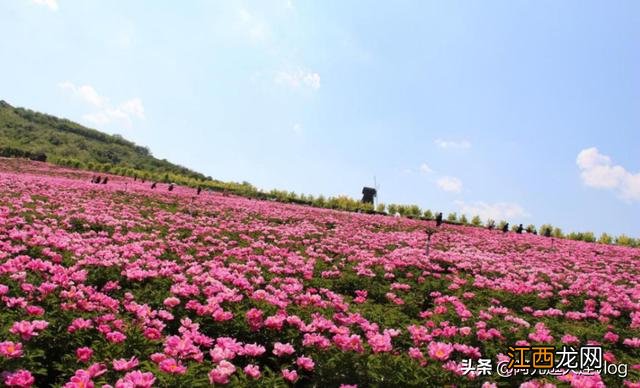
[0,100,211,180]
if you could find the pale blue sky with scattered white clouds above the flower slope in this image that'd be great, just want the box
[0,0,640,236]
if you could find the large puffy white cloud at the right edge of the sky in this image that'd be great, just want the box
[576,147,640,201]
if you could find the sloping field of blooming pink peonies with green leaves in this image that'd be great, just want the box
[0,159,640,387]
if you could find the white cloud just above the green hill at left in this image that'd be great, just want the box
[58,81,145,127]
